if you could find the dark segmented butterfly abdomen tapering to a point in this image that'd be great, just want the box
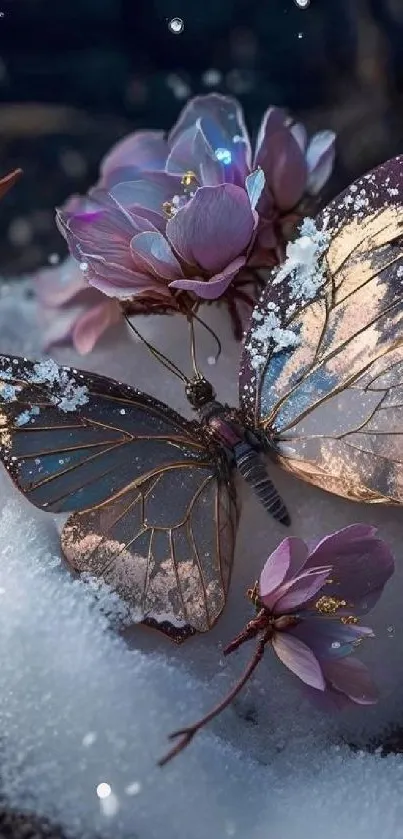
[234,441,291,525]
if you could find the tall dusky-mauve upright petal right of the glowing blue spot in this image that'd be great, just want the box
[254,108,307,211]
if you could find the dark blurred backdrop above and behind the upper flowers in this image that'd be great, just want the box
[0,0,403,274]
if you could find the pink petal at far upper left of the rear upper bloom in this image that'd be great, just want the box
[101,131,168,181]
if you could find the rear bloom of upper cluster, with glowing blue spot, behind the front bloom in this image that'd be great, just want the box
[100,93,335,213]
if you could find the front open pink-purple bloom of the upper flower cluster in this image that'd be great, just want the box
[58,170,263,304]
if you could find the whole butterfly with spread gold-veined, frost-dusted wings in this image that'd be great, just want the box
[0,158,403,641]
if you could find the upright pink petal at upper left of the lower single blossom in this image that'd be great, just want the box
[259,536,308,609]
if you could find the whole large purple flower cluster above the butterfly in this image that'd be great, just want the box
[58,94,334,307]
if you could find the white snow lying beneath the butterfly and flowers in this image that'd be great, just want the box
[0,284,403,839]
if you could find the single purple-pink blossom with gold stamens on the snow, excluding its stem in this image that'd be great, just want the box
[257,524,394,706]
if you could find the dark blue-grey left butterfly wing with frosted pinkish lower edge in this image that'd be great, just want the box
[0,356,236,641]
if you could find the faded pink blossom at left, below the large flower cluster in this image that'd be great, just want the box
[34,257,122,355]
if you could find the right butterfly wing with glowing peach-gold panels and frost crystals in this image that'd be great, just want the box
[240,157,403,504]
